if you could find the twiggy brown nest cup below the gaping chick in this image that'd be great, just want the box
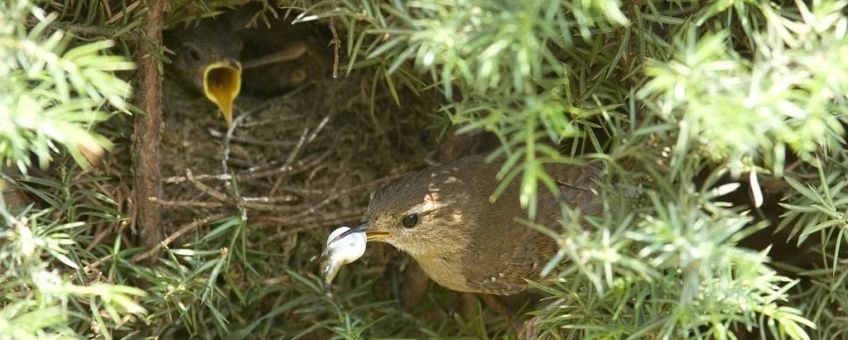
[156,33,436,268]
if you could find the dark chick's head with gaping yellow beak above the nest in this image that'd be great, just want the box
[166,20,243,126]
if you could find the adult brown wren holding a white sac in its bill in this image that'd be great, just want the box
[342,155,601,295]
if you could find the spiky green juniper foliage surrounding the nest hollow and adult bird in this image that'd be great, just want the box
[0,0,848,339]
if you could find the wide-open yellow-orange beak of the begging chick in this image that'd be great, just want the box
[203,59,241,126]
